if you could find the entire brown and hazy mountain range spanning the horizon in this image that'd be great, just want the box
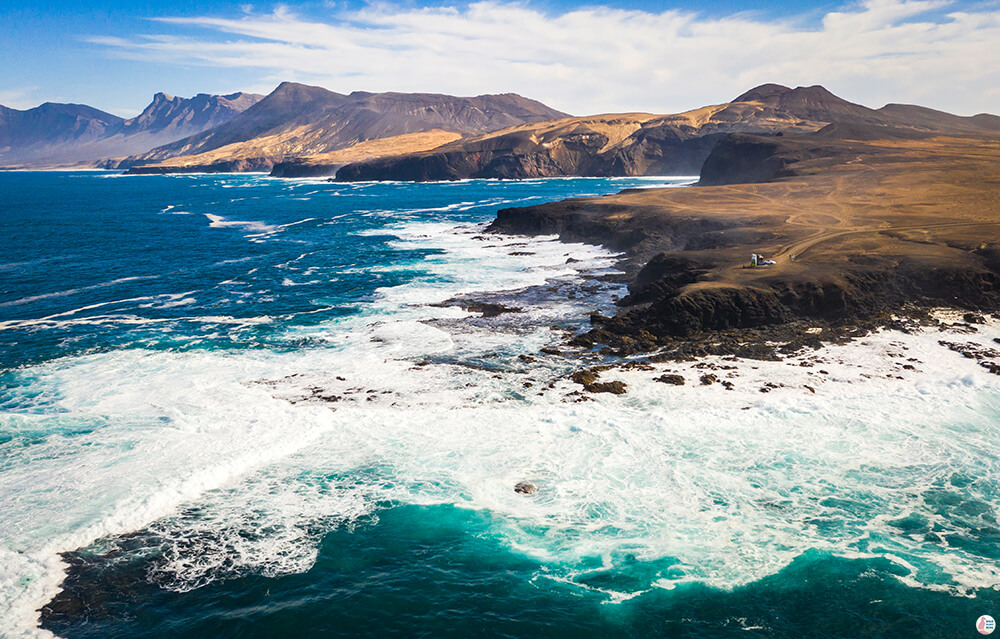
[0,82,1000,181]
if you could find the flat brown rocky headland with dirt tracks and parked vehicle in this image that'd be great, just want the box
[490,122,1000,357]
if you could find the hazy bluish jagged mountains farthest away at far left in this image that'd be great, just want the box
[0,93,262,166]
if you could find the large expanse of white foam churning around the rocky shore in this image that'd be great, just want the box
[0,214,1000,634]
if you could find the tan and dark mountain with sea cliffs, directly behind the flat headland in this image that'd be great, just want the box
[337,84,1000,181]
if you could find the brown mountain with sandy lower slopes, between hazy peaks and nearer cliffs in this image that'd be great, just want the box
[126,82,566,178]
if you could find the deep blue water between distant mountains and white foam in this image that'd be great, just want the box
[0,173,656,366]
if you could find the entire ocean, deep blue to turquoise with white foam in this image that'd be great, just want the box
[0,172,1000,638]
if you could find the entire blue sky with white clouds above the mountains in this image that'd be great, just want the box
[0,0,1000,117]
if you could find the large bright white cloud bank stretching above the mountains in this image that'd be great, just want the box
[91,0,1000,114]
